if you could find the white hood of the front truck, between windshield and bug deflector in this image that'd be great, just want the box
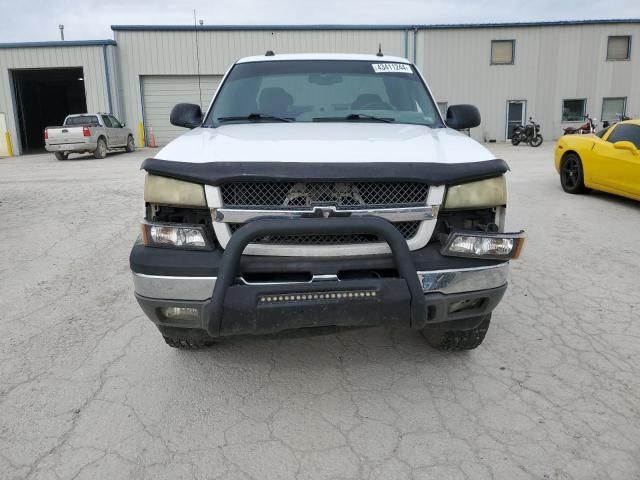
[155,122,495,164]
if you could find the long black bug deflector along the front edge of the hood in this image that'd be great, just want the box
[141,158,509,185]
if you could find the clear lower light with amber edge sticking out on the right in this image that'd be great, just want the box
[440,232,525,260]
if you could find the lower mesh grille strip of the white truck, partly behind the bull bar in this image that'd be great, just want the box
[229,222,420,245]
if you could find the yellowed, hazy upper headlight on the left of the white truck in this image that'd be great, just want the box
[144,174,207,207]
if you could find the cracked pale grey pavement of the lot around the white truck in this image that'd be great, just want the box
[0,143,640,480]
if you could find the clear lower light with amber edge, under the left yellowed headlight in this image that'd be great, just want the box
[141,222,211,250]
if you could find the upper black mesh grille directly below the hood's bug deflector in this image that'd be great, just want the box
[220,182,429,210]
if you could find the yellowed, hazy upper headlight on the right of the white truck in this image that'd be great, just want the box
[444,175,507,208]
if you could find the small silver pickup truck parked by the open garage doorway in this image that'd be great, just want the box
[44,113,136,160]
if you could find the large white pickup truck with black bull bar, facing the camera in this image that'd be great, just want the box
[130,52,524,351]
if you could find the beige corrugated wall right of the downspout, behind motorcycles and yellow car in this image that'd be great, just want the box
[417,24,640,141]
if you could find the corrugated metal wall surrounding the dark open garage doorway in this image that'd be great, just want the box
[0,45,119,154]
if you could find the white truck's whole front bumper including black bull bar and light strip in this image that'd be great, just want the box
[130,218,509,337]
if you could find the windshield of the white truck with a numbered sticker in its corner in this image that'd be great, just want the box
[203,60,443,127]
